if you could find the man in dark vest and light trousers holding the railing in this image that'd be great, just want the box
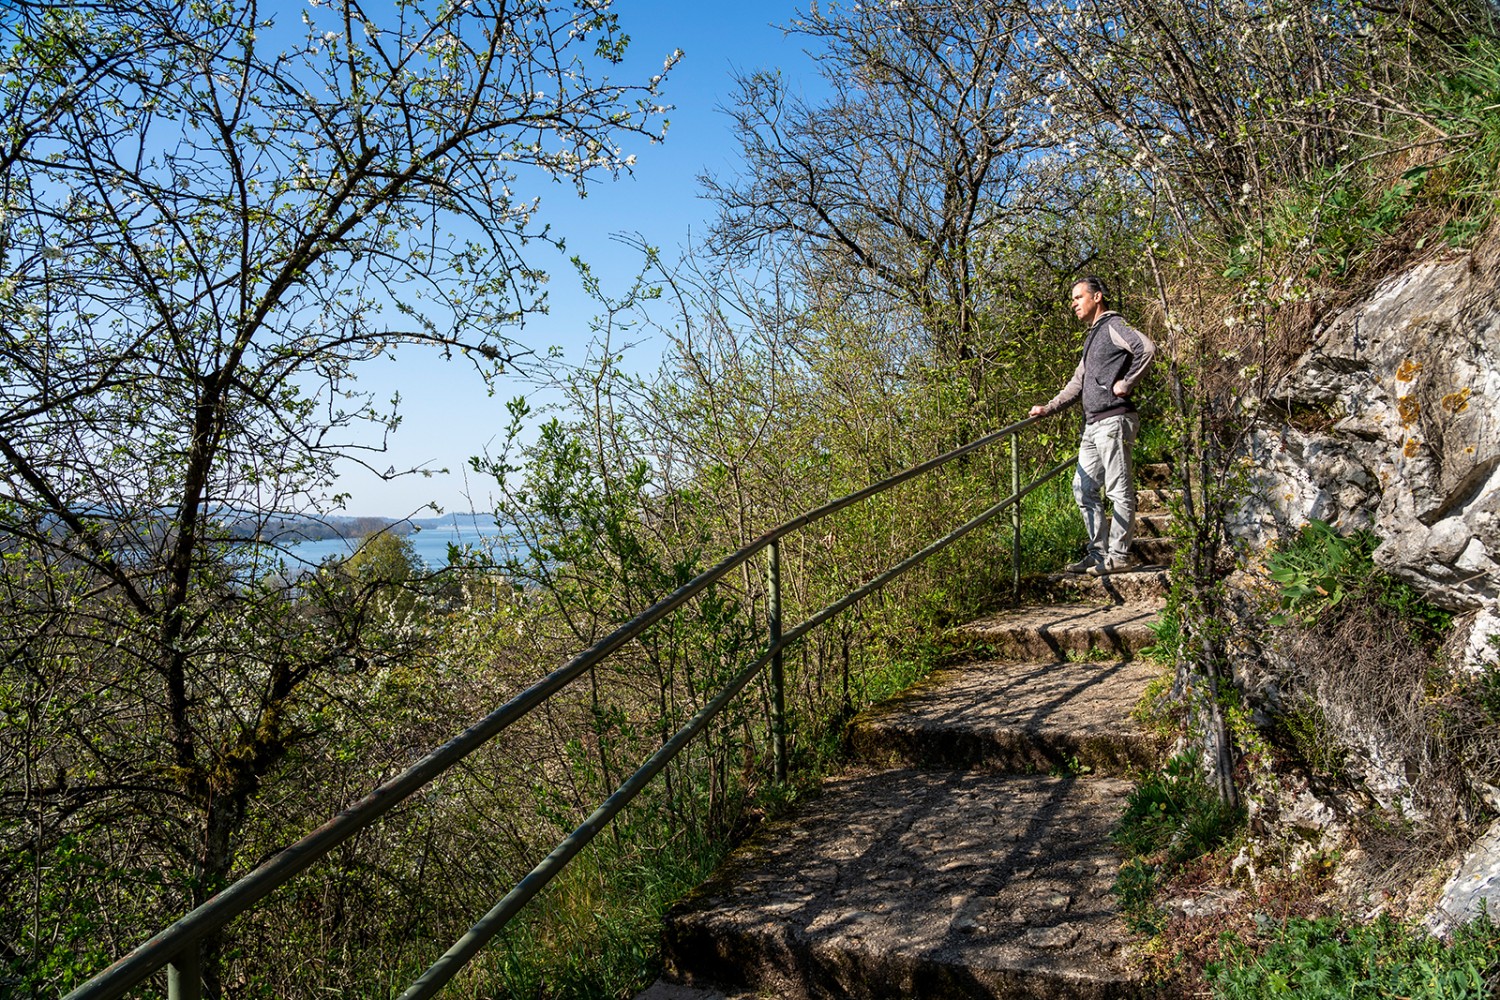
[1031,274,1157,576]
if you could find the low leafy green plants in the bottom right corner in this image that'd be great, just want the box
[1205,915,1500,1000]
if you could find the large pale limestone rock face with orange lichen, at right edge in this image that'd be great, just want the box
[1236,259,1500,632]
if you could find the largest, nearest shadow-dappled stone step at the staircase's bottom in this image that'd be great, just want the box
[663,771,1143,1000]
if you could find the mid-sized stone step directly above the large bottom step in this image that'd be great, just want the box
[848,661,1160,775]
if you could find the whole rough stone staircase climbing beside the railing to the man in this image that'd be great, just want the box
[638,470,1170,1000]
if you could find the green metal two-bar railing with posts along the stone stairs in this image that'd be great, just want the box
[66,417,1074,1000]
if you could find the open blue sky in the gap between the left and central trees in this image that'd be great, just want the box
[336,0,818,517]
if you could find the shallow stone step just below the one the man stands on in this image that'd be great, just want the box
[950,602,1158,663]
